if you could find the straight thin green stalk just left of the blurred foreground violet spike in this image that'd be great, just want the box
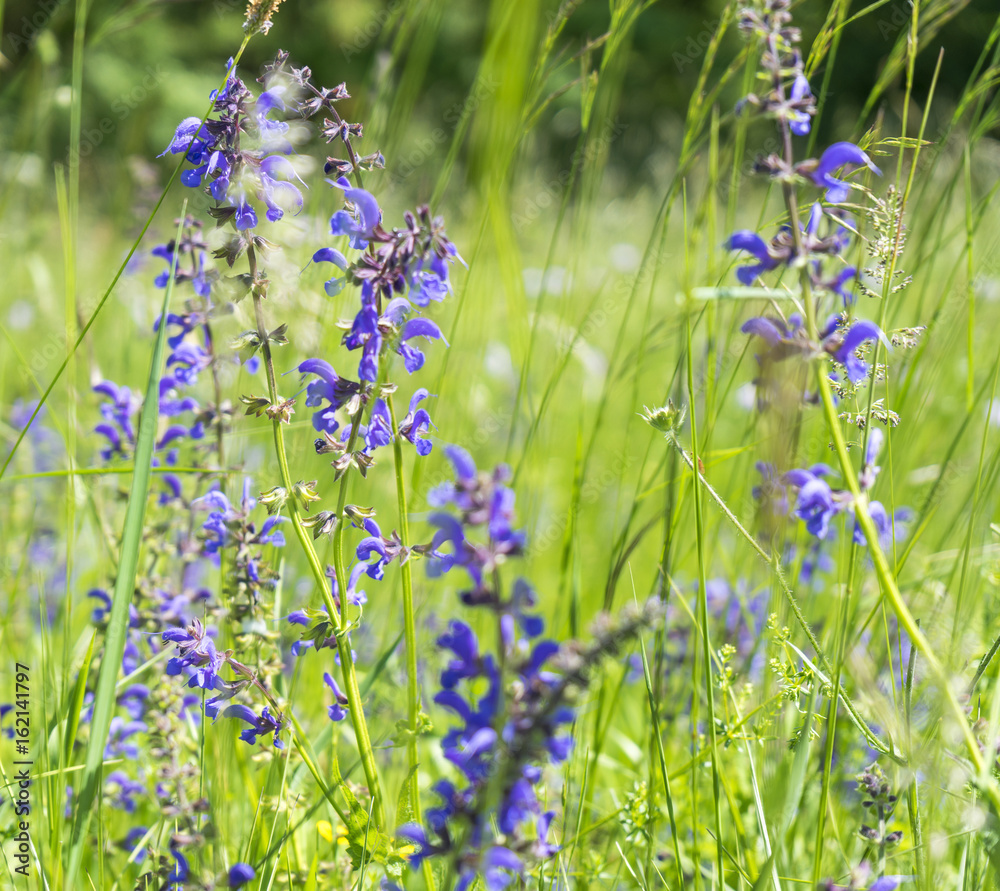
[385,393,434,889]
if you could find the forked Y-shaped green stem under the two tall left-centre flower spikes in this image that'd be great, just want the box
[247,247,385,827]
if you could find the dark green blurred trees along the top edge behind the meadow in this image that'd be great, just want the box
[0,0,996,200]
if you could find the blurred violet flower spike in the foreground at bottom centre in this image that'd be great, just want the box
[399,446,579,891]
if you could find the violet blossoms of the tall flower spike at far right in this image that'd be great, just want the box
[727,0,907,577]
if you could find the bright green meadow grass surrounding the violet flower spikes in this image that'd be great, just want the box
[0,0,1000,889]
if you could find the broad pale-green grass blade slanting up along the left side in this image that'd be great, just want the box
[65,207,187,888]
